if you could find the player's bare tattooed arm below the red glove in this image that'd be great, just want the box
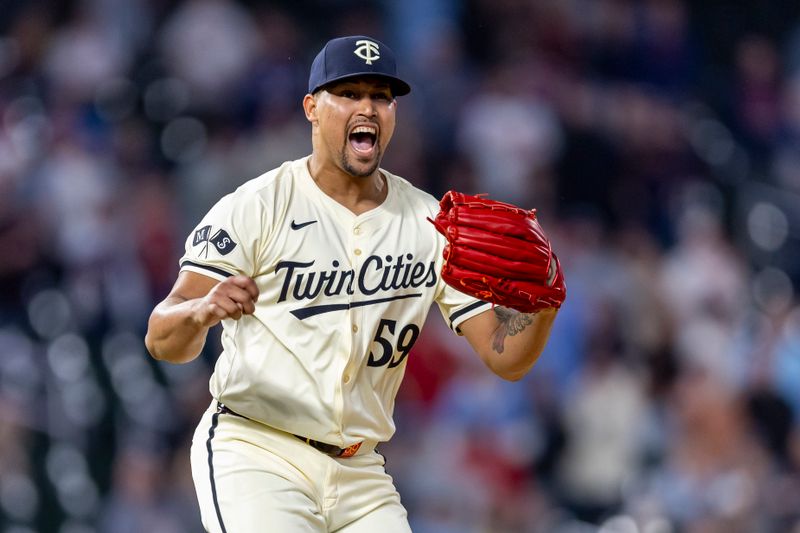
[459,305,558,381]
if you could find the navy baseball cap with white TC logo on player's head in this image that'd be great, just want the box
[308,35,411,96]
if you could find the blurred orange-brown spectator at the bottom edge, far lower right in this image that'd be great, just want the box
[632,368,767,531]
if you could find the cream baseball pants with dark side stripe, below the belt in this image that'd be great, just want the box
[191,402,411,533]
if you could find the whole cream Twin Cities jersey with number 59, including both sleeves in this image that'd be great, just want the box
[181,157,490,448]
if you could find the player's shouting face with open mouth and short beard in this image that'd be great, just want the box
[308,78,397,177]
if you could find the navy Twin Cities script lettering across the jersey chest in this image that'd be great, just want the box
[275,254,437,303]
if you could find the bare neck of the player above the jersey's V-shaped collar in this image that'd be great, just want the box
[308,154,388,215]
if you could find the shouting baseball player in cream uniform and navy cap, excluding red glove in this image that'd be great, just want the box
[145,36,556,533]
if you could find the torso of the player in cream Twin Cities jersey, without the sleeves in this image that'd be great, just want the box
[212,157,441,443]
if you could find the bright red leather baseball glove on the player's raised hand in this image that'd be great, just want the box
[429,191,567,313]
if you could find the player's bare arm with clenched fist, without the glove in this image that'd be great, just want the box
[144,270,258,363]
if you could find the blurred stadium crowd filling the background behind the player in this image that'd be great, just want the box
[0,0,800,533]
